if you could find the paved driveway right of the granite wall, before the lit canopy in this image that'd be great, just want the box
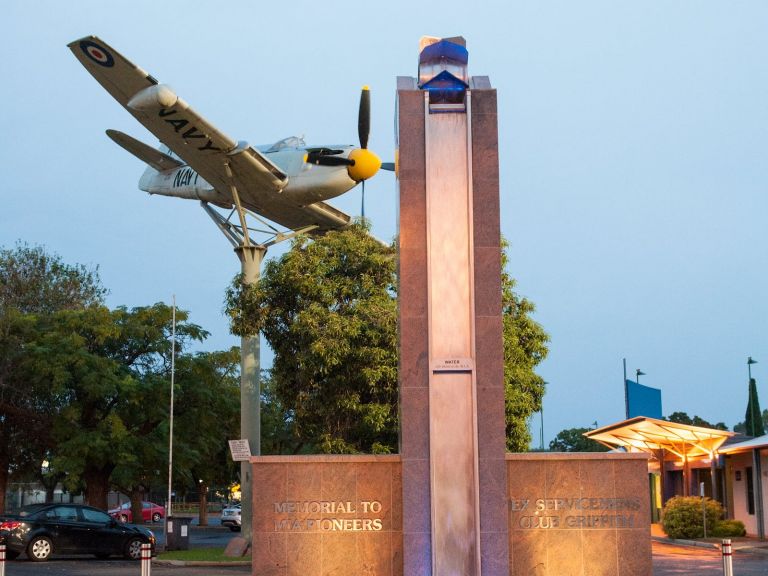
[652,542,768,576]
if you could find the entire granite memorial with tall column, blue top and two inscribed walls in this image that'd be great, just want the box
[251,38,651,576]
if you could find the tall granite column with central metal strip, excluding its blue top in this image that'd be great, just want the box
[397,66,509,576]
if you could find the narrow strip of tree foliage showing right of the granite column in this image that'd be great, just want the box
[501,241,549,452]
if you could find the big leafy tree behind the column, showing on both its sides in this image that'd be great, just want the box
[227,224,548,453]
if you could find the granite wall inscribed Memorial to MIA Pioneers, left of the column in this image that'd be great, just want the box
[251,455,403,576]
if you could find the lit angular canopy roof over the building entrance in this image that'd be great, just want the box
[584,416,736,458]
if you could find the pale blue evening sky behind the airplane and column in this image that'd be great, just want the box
[0,0,768,446]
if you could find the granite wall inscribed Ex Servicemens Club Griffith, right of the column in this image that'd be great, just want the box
[506,452,653,576]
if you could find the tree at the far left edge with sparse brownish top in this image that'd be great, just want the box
[0,243,107,511]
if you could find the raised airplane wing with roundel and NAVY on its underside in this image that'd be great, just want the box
[68,36,288,210]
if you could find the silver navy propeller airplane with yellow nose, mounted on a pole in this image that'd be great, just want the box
[68,36,393,233]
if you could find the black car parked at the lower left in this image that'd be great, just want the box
[0,504,155,562]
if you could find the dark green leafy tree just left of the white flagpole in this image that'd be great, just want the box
[27,304,205,508]
